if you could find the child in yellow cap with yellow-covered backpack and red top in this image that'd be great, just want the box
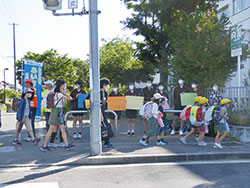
[180,96,208,146]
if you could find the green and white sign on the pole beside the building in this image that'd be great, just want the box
[231,27,242,57]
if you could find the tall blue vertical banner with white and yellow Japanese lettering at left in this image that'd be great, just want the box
[22,60,43,121]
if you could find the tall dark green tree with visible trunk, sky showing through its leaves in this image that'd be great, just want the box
[121,0,218,86]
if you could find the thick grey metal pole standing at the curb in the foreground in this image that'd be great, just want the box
[89,0,102,155]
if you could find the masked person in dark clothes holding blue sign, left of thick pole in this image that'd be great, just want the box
[70,80,86,139]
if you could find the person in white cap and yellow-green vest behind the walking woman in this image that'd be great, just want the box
[42,80,54,131]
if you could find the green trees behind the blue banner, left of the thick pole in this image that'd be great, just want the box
[17,49,88,87]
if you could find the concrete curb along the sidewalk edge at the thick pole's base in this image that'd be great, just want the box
[65,152,250,166]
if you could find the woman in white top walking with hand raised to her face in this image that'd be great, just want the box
[40,79,74,152]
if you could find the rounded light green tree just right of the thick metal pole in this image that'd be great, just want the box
[100,38,154,85]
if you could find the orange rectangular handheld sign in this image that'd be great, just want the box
[108,97,126,111]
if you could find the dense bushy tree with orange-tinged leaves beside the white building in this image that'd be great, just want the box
[167,6,248,89]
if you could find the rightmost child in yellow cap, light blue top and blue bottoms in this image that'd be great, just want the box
[213,98,231,149]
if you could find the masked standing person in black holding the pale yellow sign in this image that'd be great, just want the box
[125,82,138,136]
